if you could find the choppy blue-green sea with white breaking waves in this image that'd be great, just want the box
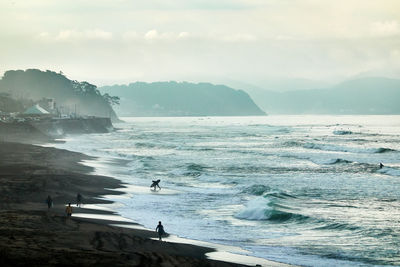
[58,116,400,266]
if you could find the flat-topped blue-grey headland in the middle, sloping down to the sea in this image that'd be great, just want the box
[99,82,265,116]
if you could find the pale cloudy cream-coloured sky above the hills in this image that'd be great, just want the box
[0,0,400,87]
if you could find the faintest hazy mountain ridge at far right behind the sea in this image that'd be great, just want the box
[250,77,400,114]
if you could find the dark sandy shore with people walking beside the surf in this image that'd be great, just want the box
[0,142,290,266]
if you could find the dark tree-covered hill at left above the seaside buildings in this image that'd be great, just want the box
[0,69,119,121]
